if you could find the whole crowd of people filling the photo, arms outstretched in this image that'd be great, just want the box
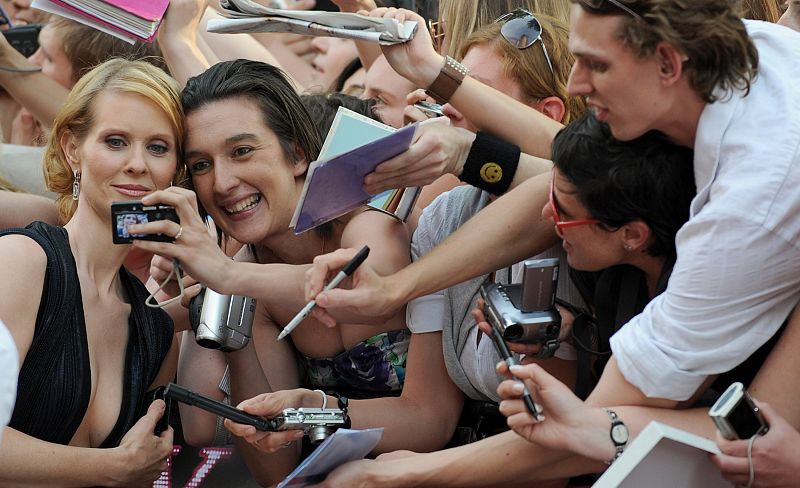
[0,0,800,487]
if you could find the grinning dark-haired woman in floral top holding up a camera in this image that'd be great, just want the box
[136,60,462,485]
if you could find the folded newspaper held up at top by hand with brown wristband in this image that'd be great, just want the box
[208,0,417,44]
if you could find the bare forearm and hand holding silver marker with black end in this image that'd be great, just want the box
[306,175,556,320]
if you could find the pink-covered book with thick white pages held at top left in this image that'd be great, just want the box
[32,0,169,43]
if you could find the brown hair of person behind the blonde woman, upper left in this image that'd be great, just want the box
[47,16,167,84]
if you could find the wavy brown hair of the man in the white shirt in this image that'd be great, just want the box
[570,0,758,103]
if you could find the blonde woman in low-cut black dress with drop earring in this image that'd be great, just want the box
[0,59,183,486]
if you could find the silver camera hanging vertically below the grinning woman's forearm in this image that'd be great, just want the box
[189,287,256,352]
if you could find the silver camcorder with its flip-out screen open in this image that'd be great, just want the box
[481,258,561,351]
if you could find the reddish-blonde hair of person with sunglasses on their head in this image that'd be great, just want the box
[459,14,586,124]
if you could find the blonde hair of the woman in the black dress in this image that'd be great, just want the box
[44,58,186,222]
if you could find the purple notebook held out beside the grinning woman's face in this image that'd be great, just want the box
[294,124,417,234]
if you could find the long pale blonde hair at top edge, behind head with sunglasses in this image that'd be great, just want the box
[439,0,569,59]
